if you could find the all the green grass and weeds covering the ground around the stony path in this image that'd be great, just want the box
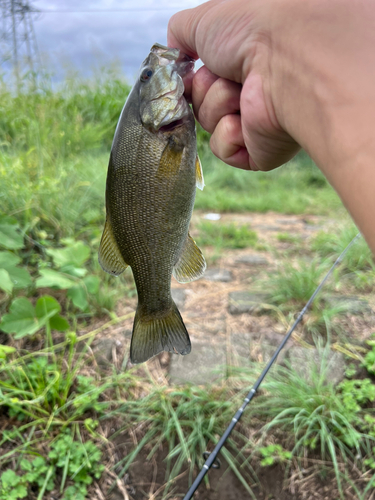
[0,71,375,500]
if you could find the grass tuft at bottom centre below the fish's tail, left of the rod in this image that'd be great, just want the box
[109,386,253,495]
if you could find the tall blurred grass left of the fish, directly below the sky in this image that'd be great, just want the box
[0,71,130,238]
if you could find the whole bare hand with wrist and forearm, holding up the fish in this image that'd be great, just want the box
[168,0,375,253]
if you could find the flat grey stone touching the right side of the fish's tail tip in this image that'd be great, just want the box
[169,337,226,385]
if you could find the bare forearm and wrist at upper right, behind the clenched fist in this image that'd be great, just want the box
[269,0,375,252]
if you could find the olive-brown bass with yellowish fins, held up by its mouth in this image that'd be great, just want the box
[99,43,206,364]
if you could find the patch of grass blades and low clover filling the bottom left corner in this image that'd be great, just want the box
[0,318,127,500]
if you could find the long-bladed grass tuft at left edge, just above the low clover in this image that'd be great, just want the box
[0,332,108,425]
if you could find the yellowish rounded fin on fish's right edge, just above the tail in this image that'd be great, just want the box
[173,234,206,283]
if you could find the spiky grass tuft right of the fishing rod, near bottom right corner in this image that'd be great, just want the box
[250,344,374,498]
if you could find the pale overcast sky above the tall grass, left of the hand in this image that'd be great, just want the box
[30,0,203,82]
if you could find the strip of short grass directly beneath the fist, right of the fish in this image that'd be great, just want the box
[195,147,343,214]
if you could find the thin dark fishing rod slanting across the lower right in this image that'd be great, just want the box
[183,233,361,500]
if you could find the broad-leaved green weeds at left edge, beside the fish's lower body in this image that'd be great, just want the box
[0,211,129,316]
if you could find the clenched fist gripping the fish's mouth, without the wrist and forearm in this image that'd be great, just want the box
[168,0,299,170]
